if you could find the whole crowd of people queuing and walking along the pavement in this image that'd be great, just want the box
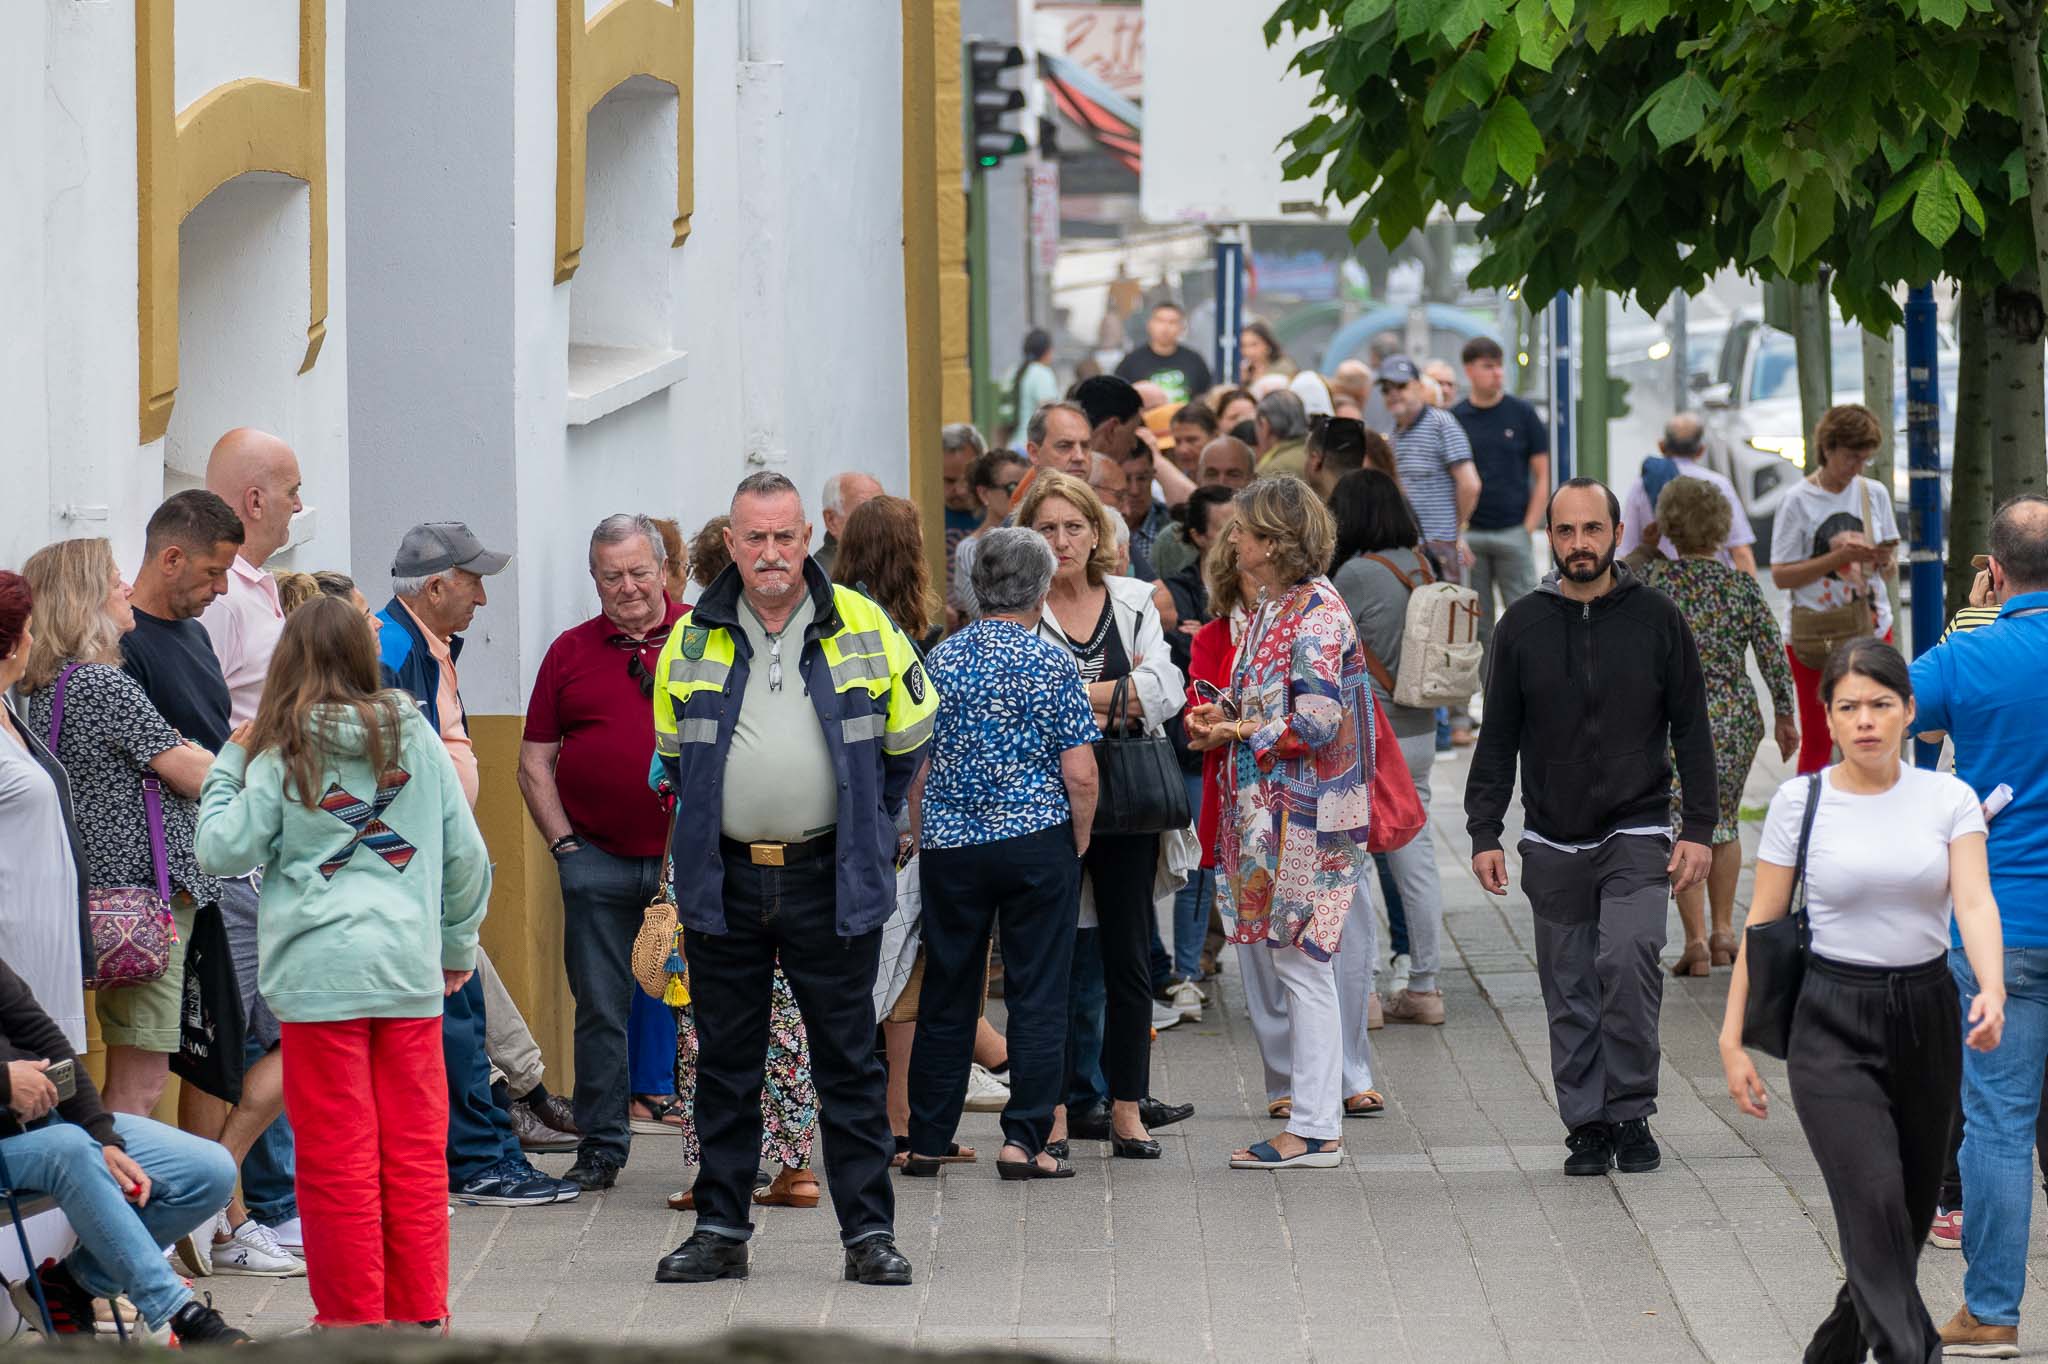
[0,315,2048,1358]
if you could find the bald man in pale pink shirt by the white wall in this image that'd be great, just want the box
[199,426,305,725]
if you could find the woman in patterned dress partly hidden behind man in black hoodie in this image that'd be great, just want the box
[1642,477,1798,975]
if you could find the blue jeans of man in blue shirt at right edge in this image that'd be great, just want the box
[1948,948,2048,1325]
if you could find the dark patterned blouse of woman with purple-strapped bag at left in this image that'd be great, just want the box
[27,664,221,905]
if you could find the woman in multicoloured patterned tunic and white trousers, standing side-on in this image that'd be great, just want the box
[1188,477,1372,1169]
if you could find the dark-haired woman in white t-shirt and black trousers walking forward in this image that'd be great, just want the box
[1720,639,2005,1360]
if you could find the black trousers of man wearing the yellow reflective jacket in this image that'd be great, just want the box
[682,852,895,1245]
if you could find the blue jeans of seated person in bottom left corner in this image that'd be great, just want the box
[0,1112,236,1329]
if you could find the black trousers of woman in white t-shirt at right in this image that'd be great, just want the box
[1786,954,1962,1364]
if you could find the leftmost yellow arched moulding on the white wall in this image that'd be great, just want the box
[135,0,328,444]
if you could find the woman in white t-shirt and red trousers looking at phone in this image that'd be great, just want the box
[1772,403,1898,776]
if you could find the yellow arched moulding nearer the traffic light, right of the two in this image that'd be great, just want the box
[555,0,696,285]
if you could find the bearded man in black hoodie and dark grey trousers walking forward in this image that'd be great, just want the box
[1464,479,1716,1176]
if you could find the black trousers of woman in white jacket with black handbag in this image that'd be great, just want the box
[1081,834,1159,1104]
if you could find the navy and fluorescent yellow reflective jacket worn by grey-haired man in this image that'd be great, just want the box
[653,559,938,938]
